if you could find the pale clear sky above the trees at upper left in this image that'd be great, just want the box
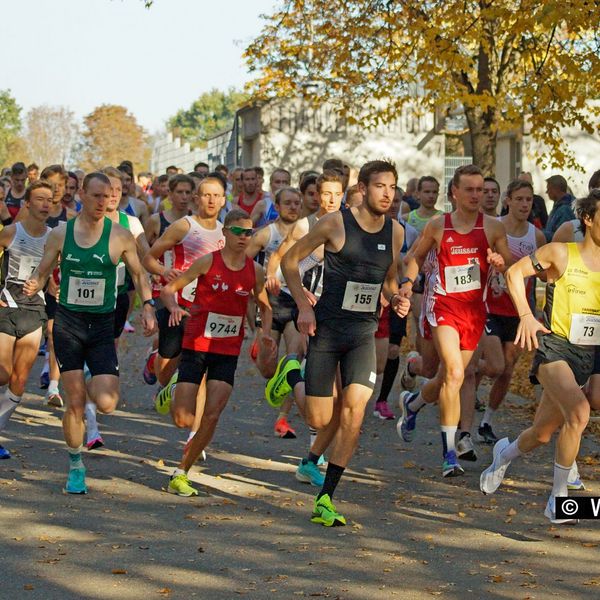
[0,0,277,133]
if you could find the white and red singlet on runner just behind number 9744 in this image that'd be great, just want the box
[173,216,225,307]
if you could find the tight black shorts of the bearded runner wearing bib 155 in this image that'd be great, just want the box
[305,323,376,397]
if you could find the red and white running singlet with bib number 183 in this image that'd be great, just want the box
[432,213,489,303]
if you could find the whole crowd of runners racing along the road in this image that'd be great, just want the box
[0,159,600,526]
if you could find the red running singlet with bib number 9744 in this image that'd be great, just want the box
[182,252,256,356]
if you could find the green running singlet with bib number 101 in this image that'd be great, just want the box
[58,217,117,313]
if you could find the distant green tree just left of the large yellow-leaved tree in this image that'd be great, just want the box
[167,88,248,147]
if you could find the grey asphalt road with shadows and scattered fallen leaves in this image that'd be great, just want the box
[0,326,600,600]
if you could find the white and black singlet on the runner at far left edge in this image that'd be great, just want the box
[0,222,51,310]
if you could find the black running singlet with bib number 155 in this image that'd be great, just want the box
[315,210,393,334]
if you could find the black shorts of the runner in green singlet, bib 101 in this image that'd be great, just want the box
[53,304,119,376]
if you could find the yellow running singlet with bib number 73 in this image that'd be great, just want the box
[544,243,600,346]
